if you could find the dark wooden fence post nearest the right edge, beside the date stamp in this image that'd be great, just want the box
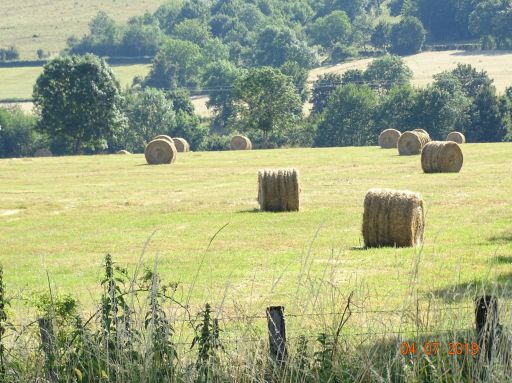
[475,295,499,362]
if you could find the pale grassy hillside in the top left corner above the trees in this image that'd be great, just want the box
[0,0,164,59]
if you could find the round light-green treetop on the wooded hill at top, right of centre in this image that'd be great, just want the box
[310,11,352,48]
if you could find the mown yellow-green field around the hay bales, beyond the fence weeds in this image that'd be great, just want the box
[0,144,512,323]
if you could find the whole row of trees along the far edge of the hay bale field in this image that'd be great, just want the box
[0,55,512,157]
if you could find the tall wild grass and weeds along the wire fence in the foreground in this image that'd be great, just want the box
[0,242,512,383]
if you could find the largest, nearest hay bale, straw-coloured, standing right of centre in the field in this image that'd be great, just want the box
[363,189,425,247]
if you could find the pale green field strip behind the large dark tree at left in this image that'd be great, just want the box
[0,64,151,100]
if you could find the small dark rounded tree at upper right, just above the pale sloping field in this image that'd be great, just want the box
[391,16,426,55]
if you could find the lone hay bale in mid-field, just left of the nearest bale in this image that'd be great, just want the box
[258,169,300,211]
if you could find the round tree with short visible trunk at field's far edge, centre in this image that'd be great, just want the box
[232,67,302,147]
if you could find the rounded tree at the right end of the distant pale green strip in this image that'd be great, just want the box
[145,40,203,89]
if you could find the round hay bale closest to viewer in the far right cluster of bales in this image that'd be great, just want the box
[421,141,464,173]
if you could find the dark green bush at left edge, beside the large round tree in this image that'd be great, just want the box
[0,107,47,157]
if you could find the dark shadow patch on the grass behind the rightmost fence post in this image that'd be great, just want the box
[431,274,512,303]
